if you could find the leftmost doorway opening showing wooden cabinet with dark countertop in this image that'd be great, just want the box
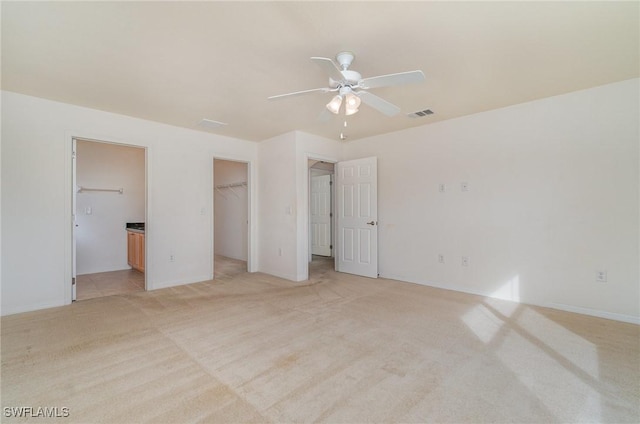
[72,138,146,300]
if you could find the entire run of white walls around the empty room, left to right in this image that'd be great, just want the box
[0,80,640,321]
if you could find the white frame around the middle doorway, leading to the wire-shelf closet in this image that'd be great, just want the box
[210,155,258,280]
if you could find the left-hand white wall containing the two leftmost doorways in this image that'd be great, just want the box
[1,91,257,315]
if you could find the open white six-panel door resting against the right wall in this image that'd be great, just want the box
[336,157,378,278]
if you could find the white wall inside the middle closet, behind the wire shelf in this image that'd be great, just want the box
[213,160,248,261]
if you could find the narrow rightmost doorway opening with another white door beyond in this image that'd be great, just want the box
[308,159,335,279]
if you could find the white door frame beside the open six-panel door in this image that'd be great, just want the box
[298,153,339,281]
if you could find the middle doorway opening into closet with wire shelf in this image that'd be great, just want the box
[213,159,249,279]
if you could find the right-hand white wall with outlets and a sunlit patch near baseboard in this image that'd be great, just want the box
[345,79,640,322]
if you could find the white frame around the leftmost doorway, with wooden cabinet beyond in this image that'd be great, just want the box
[63,131,153,305]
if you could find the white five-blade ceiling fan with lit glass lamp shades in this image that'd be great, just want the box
[268,52,425,116]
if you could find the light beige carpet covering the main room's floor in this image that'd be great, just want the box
[1,261,640,423]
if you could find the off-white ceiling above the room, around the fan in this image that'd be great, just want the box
[2,1,640,141]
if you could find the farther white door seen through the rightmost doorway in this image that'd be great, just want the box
[310,175,331,256]
